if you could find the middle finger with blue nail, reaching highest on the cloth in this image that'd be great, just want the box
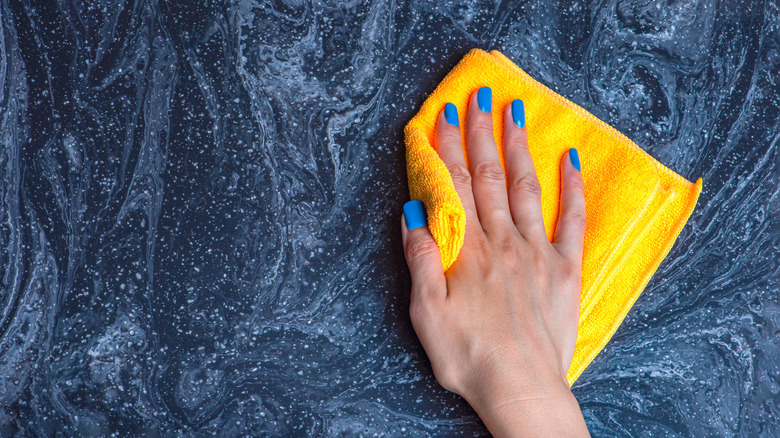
[466,87,511,232]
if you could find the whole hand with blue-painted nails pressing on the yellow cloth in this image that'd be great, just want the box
[402,87,588,436]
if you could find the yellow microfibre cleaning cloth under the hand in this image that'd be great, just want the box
[404,49,702,384]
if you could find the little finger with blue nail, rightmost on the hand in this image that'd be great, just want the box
[553,149,586,266]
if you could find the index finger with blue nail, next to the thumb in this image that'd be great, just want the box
[436,103,482,233]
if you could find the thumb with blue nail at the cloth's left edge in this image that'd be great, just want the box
[401,201,447,301]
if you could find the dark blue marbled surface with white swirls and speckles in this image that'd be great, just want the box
[0,0,780,437]
